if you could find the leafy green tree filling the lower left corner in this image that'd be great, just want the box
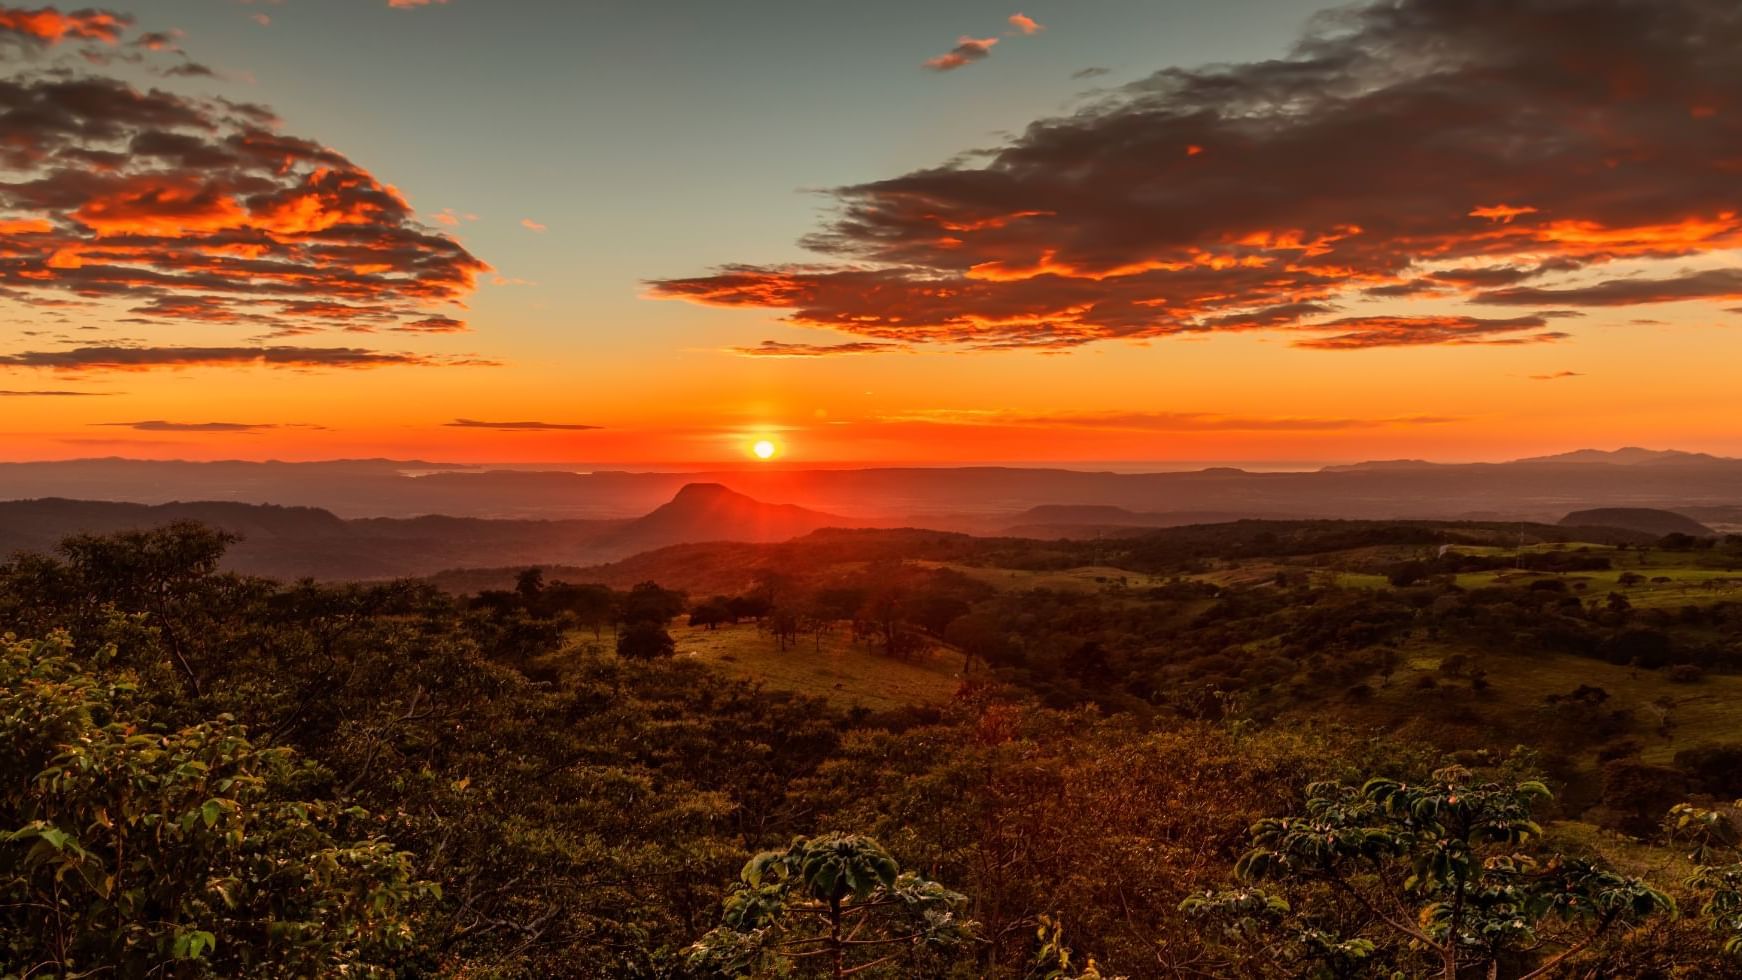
[0,642,436,978]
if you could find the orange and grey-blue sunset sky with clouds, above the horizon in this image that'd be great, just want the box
[0,0,1742,467]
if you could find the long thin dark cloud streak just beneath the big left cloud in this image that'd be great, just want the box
[0,346,488,373]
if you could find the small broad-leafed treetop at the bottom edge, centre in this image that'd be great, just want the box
[686,834,974,980]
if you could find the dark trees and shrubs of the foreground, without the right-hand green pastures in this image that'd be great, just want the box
[10,526,1742,980]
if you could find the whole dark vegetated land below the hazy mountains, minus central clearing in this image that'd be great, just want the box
[0,522,1742,980]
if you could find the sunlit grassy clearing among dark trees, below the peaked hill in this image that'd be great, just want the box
[671,623,962,710]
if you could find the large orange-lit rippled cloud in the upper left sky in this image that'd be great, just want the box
[0,7,488,341]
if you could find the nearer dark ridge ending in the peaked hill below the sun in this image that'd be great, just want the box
[0,484,864,580]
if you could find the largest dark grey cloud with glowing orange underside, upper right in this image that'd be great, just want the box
[650,0,1742,350]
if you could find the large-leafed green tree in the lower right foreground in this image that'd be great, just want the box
[1185,766,1674,980]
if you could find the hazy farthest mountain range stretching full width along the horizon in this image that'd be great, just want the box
[0,447,1742,529]
